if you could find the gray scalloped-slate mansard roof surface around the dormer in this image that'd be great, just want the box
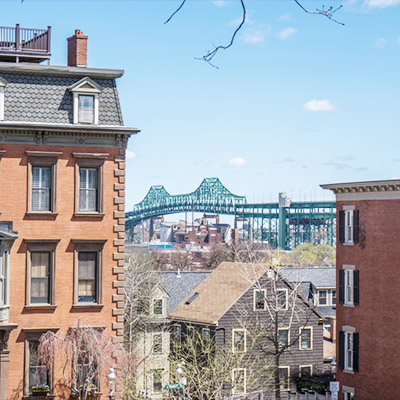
[0,70,123,126]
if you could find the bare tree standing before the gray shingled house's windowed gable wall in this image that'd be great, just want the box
[234,254,322,400]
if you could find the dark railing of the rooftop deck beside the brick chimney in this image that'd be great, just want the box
[0,24,51,55]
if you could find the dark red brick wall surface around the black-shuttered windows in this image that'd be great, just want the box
[336,200,400,400]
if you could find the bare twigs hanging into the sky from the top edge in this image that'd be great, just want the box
[164,0,344,68]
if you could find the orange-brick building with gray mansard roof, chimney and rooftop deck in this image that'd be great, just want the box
[0,26,138,400]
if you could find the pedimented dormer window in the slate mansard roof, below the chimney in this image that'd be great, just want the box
[69,78,103,125]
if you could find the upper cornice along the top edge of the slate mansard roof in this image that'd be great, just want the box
[0,62,124,79]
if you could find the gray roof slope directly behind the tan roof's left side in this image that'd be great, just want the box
[160,271,211,314]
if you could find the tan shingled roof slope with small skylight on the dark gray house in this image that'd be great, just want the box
[169,262,268,324]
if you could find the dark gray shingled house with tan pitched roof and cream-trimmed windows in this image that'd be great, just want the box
[168,262,325,399]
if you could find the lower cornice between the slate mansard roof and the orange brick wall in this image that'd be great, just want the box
[0,121,140,135]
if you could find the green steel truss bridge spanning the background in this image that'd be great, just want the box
[126,178,336,250]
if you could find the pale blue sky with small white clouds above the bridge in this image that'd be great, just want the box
[0,0,400,210]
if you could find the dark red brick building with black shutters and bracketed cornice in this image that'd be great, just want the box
[321,180,400,400]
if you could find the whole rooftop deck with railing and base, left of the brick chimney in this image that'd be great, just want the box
[0,24,51,63]
